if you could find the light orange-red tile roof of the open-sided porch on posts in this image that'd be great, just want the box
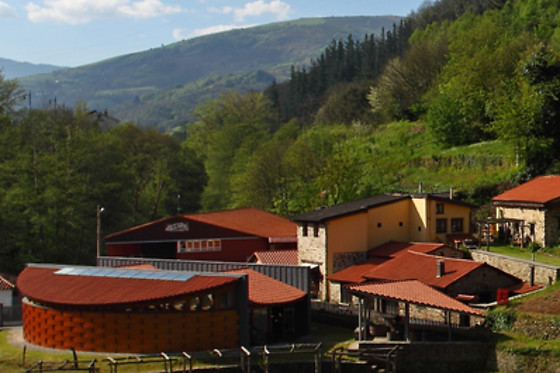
[348,280,484,316]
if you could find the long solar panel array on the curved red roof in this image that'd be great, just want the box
[55,267,196,281]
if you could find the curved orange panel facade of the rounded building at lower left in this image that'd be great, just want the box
[22,302,239,353]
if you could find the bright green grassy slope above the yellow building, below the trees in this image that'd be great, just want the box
[374,122,519,198]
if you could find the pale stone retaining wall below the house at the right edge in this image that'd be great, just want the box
[471,250,560,286]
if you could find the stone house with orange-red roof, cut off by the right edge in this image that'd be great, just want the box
[492,175,560,247]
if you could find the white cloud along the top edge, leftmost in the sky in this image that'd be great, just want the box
[25,0,182,25]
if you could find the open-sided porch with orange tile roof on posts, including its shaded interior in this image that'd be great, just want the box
[348,280,485,343]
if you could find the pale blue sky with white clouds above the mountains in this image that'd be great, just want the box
[0,0,425,67]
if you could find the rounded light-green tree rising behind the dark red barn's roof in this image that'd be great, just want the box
[187,92,276,211]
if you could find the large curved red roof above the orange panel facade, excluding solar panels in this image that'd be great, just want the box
[17,266,238,306]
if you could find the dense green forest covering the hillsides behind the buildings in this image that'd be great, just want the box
[0,0,560,272]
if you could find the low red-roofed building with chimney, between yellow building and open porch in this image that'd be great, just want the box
[328,242,540,303]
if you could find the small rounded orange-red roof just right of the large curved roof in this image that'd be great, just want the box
[226,268,306,305]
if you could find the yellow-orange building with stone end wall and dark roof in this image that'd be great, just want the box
[292,193,473,300]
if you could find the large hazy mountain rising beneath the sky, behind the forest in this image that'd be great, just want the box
[16,16,401,130]
